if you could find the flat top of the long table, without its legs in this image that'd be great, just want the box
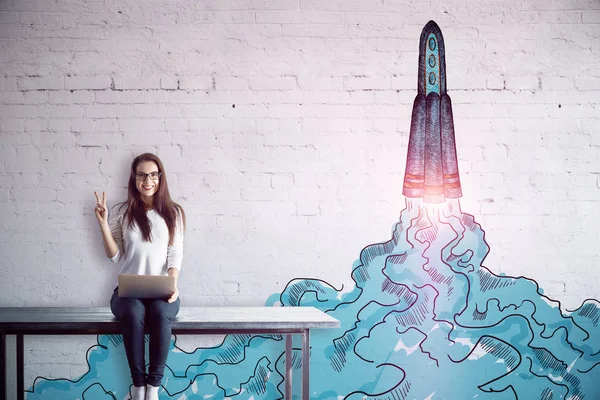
[0,307,340,334]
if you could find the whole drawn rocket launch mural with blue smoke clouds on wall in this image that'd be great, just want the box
[27,22,600,400]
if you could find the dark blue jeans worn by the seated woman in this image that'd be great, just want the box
[110,287,180,386]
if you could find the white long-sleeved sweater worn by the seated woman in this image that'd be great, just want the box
[109,206,183,286]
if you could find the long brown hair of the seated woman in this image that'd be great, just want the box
[116,153,185,246]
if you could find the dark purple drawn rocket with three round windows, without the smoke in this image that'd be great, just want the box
[402,21,462,203]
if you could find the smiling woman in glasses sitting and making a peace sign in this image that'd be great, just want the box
[94,153,185,400]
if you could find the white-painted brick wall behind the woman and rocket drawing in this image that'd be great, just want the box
[0,0,600,396]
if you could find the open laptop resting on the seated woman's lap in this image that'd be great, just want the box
[118,274,175,299]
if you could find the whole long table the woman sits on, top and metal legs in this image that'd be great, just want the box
[0,307,340,400]
